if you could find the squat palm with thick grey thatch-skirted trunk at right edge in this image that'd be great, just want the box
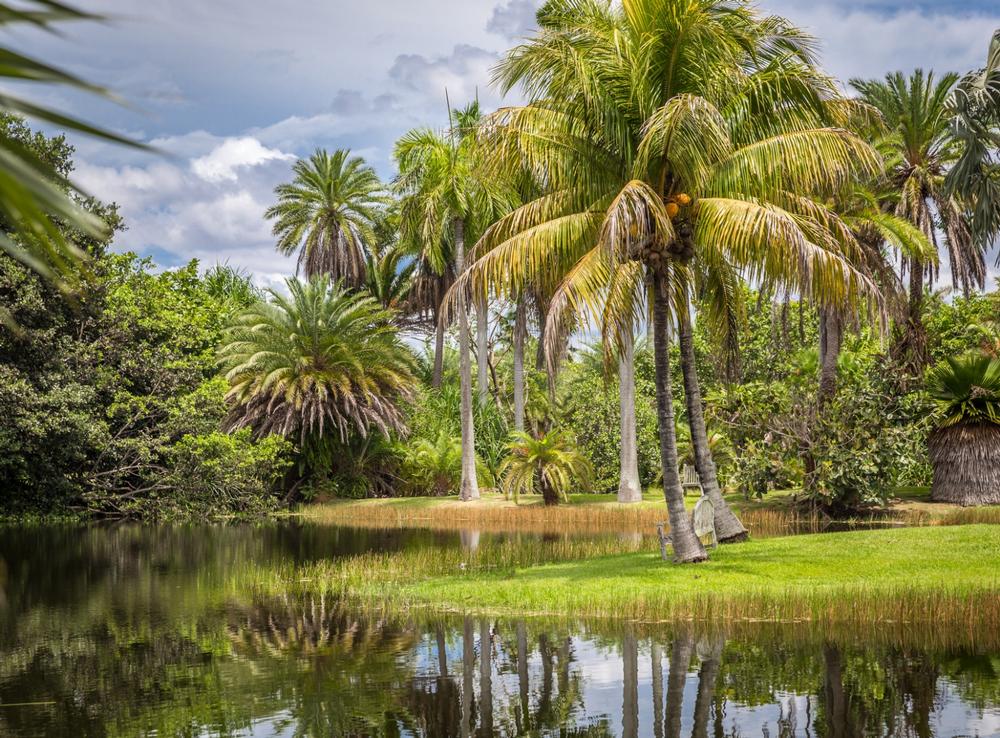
[928,353,1000,505]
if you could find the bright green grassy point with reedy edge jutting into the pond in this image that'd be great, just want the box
[256,525,1000,628]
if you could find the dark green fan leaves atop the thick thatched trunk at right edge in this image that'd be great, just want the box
[927,353,1000,427]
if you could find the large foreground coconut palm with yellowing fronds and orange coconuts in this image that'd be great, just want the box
[456,0,878,562]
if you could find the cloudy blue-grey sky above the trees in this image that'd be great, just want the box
[12,0,1000,285]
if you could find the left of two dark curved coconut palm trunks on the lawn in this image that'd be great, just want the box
[652,268,708,563]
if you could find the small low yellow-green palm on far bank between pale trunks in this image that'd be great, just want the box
[503,430,592,505]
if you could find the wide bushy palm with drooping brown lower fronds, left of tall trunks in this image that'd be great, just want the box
[220,276,416,473]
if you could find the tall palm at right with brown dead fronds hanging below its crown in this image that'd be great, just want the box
[851,69,986,369]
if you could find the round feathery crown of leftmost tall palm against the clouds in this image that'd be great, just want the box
[265,149,389,288]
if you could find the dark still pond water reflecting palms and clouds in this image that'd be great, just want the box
[0,523,1000,738]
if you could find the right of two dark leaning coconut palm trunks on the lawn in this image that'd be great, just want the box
[677,300,748,543]
